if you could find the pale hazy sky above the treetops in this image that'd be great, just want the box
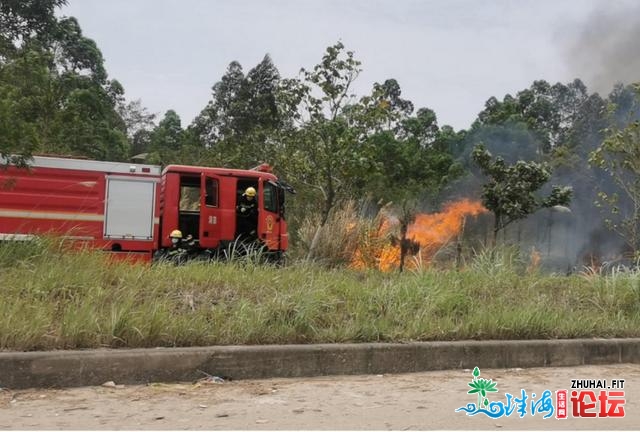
[61,0,640,129]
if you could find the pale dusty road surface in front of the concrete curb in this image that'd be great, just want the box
[0,365,640,430]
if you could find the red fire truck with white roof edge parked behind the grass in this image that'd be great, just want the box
[0,156,294,260]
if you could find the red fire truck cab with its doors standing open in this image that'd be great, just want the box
[160,165,289,258]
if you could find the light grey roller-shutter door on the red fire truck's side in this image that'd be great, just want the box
[104,176,156,240]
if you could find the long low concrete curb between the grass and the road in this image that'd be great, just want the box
[0,338,640,389]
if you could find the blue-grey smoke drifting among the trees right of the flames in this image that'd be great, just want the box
[445,111,626,273]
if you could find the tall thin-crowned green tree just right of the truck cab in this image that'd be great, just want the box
[290,42,364,228]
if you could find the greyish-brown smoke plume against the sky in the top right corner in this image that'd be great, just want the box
[565,2,640,94]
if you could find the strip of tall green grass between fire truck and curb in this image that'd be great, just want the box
[0,241,640,350]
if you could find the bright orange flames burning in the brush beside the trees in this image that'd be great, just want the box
[351,199,487,271]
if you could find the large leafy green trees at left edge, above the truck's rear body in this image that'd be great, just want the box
[0,0,134,160]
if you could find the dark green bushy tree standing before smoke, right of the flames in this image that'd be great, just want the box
[473,144,573,246]
